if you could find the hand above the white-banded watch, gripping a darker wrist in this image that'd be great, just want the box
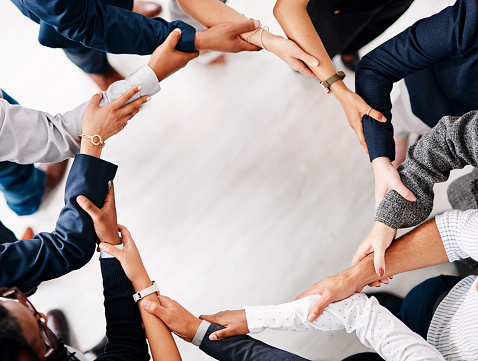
[99,224,151,282]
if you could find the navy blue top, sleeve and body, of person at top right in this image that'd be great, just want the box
[356,0,478,160]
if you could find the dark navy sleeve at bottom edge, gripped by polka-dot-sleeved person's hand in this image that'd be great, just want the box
[199,324,307,361]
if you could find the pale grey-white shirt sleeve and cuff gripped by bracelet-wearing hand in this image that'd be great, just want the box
[0,65,160,164]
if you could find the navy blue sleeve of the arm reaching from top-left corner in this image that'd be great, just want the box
[12,0,196,55]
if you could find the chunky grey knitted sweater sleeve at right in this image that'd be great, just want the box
[375,111,478,229]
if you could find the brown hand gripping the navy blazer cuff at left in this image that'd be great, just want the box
[76,186,121,244]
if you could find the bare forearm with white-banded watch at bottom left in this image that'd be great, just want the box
[133,270,181,361]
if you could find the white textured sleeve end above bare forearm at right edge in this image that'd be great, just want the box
[435,209,478,262]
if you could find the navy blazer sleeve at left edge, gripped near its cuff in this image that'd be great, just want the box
[0,154,117,287]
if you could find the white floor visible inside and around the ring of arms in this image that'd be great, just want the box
[0,0,464,360]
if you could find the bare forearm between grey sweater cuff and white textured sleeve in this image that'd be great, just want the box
[352,219,448,292]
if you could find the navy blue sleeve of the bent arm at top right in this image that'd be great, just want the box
[355,0,477,161]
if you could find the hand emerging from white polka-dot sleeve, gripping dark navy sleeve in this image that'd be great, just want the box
[199,310,249,341]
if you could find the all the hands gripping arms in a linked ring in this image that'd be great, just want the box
[77,16,424,341]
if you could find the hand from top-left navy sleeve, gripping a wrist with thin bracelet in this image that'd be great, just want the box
[194,20,261,53]
